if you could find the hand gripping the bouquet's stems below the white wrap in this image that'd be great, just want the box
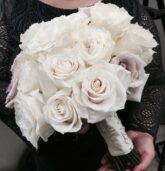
[98,131,155,171]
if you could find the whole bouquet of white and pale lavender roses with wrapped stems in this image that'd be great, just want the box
[6,2,157,171]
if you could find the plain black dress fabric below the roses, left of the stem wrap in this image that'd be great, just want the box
[21,125,107,171]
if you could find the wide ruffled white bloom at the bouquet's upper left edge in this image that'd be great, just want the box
[20,12,89,54]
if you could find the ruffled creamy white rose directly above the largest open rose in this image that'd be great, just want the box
[72,25,115,64]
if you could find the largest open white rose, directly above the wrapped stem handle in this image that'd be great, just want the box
[73,61,131,123]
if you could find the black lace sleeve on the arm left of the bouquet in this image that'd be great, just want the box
[0,0,35,148]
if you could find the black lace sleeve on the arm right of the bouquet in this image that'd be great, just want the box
[121,1,165,137]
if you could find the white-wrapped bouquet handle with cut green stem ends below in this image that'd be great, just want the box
[97,113,140,171]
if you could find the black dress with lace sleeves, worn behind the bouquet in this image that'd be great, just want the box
[0,0,165,171]
